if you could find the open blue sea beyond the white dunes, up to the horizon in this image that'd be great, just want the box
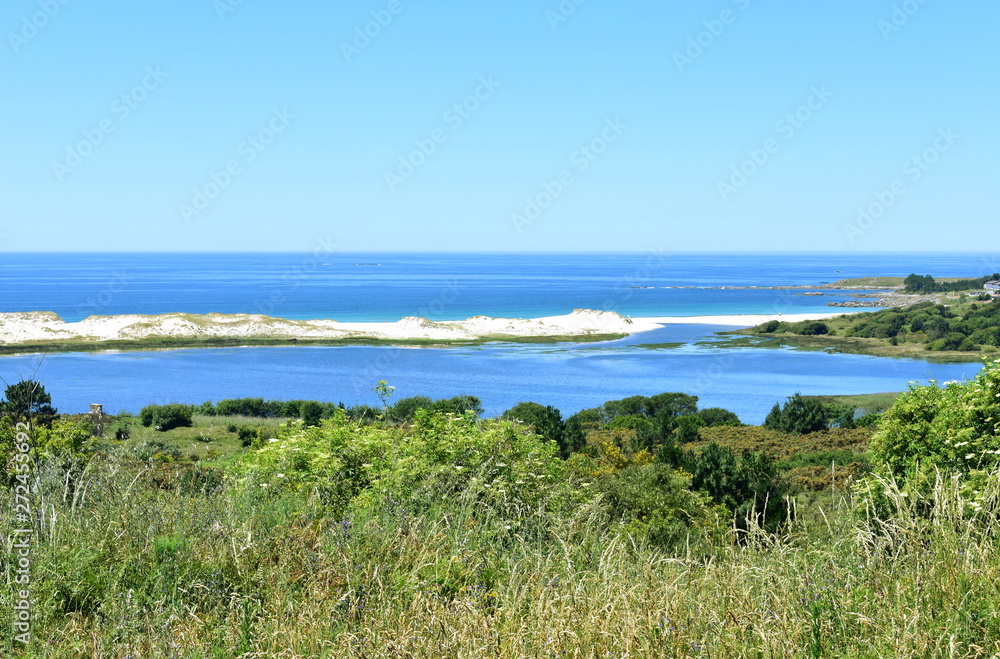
[0,252,1000,321]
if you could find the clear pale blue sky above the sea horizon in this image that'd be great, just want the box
[0,0,1000,252]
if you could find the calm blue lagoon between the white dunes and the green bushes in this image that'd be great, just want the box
[0,325,980,423]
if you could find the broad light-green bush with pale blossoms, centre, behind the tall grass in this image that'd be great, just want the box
[231,411,561,515]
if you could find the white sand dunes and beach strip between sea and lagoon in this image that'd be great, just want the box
[0,309,843,345]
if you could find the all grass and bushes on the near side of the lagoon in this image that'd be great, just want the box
[0,374,1000,659]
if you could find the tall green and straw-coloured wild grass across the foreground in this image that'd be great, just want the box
[0,458,1000,658]
